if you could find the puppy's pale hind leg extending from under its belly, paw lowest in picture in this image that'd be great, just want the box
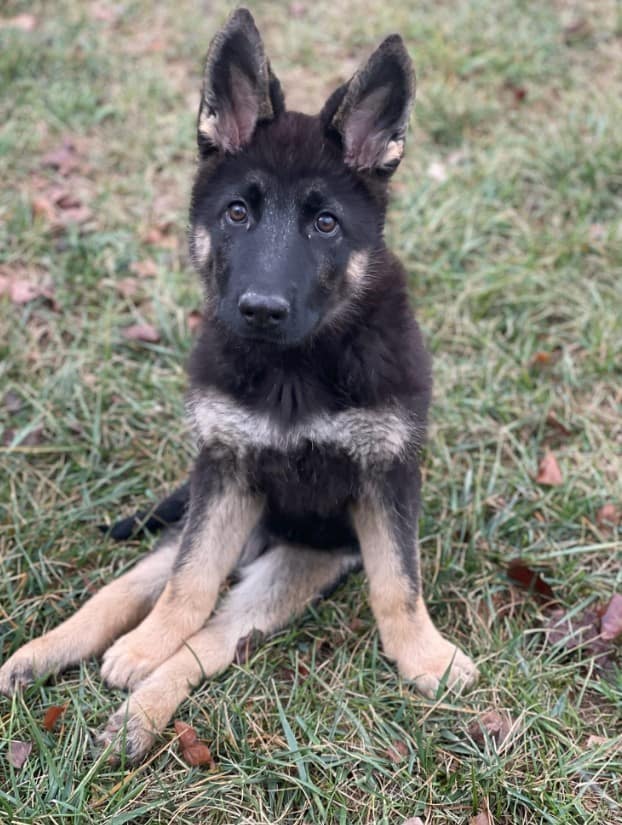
[101,545,360,761]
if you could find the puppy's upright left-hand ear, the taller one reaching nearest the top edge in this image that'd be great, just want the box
[198,9,285,156]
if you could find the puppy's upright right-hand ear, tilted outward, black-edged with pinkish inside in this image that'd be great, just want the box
[320,34,415,174]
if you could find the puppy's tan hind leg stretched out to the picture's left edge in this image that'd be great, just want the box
[0,531,181,695]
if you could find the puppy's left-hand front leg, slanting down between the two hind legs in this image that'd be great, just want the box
[102,451,261,687]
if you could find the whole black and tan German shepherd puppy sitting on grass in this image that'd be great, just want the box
[0,9,477,760]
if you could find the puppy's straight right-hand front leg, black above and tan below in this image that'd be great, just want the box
[353,465,478,697]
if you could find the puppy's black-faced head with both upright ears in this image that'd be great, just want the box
[190,9,414,348]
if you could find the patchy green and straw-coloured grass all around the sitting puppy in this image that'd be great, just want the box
[0,0,622,825]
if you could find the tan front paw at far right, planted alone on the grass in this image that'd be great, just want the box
[398,636,479,699]
